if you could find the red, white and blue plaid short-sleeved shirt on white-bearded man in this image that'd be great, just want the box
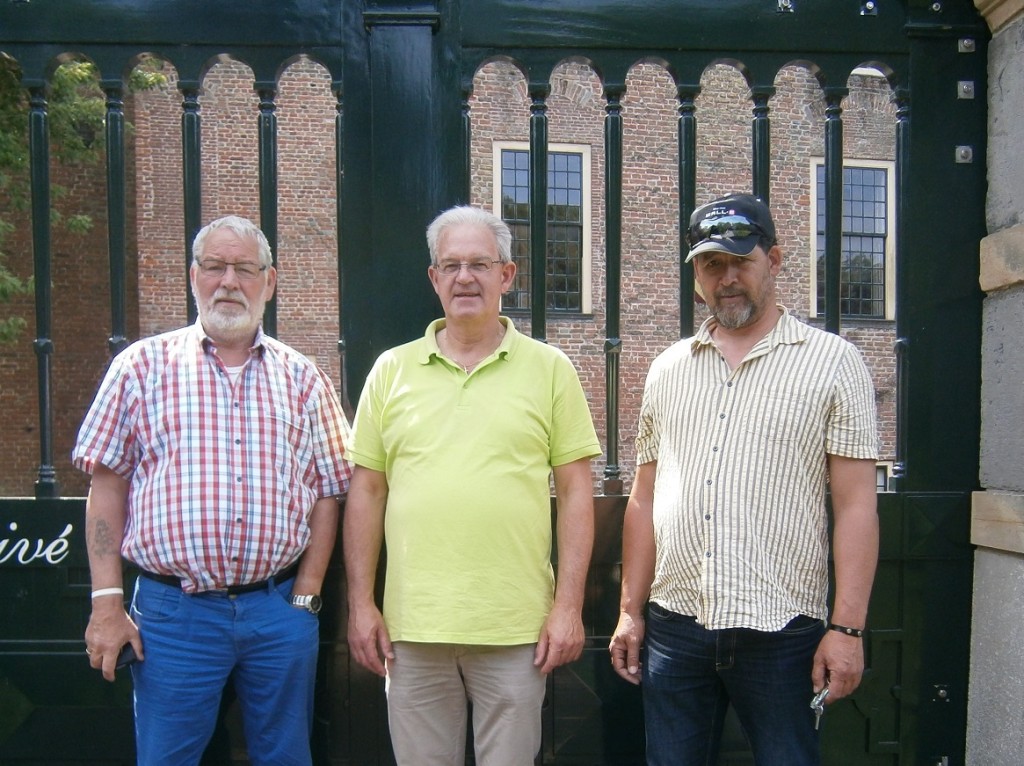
[72,323,352,593]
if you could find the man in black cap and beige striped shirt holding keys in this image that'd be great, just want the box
[609,195,878,766]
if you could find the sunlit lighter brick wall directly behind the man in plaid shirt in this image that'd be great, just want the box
[130,60,340,385]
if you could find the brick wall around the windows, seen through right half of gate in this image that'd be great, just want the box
[470,62,895,490]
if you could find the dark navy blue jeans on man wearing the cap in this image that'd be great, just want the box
[641,603,825,766]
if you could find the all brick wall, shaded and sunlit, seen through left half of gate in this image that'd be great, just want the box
[0,55,340,496]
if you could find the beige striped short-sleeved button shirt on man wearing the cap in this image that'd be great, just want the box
[636,307,878,631]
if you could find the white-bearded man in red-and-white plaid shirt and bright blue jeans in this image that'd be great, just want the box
[73,216,351,766]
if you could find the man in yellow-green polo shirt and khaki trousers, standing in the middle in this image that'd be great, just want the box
[344,207,601,766]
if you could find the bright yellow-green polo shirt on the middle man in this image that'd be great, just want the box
[350,317,601,645]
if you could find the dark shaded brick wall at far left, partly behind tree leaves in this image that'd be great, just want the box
[0,94,138,497]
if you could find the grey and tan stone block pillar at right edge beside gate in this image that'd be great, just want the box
[967,0,1024,766]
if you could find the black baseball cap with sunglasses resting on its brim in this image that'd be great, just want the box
[685,195,775,263]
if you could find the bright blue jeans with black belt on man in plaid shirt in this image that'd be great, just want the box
[131,578,318,766]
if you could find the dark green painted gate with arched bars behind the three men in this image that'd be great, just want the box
[0,0,987,766]
